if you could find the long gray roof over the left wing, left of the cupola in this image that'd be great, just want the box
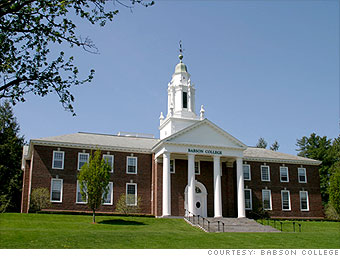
[31,132,159,151]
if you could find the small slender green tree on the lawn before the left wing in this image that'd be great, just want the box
[78,150,111,223]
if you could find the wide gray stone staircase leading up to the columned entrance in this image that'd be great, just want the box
[184,216,280,232]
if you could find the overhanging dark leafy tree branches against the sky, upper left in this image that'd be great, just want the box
[0,0,154,114]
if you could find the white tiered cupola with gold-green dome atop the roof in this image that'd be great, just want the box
[159,49,202,139]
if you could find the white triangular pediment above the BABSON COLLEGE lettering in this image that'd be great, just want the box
[164,119,246,149]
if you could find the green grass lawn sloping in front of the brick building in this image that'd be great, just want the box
[0,213,340,249]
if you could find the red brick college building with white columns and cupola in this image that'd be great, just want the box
[21,55,323,218]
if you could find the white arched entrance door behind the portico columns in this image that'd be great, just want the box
[184,180,208,217]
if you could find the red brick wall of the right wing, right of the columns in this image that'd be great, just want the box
[244,161,324,218]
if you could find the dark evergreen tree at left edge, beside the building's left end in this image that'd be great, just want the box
[0,101,24,212]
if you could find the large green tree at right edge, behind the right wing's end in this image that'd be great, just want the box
[296,133,340,204]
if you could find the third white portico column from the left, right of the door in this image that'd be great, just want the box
[214,156,222,218]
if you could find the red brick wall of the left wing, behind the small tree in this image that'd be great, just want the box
[24,146,152,214]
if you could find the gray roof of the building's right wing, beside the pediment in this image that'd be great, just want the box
[243,147,321,165]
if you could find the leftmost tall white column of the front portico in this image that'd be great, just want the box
[162,152,171,216]
